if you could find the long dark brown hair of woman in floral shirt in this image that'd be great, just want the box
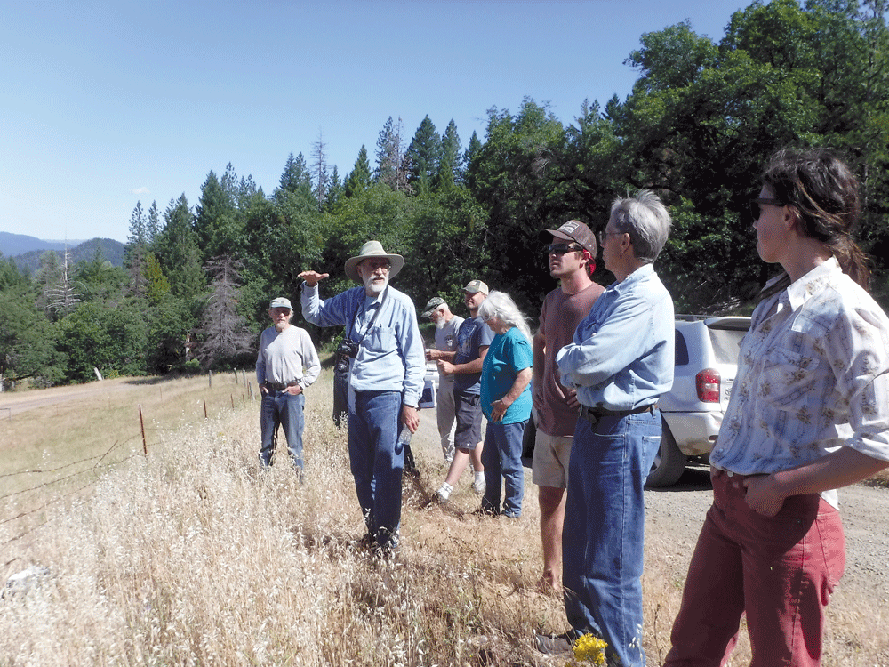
[762,149,870,297]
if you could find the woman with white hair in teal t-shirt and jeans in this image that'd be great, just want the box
[478,291,534,518]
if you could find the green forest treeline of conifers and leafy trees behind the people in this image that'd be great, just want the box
[0,0,889,386]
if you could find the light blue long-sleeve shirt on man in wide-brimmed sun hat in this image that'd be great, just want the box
[300,283,426,407]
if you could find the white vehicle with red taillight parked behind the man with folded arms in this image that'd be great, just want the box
[646,315,750,487]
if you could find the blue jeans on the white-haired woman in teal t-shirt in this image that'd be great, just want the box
[482,421,528,519]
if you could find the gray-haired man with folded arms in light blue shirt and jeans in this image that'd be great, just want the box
[537,190,675,667]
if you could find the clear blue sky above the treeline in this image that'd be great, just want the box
[0,0,749,241]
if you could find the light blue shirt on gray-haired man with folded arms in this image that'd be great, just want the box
[556,264,676,410]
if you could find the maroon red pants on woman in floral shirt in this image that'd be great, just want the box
[664,471,846,667]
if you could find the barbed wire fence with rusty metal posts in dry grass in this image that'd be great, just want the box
[0,371,255,565]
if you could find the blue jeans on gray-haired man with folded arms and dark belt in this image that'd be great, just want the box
[562,410,661,667]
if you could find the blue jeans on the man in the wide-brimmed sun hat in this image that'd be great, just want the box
[349,391,404,549]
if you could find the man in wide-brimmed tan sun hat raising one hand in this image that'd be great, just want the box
[299,241,426,554]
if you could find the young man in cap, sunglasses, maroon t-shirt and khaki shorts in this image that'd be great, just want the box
[532,220,605,591]
